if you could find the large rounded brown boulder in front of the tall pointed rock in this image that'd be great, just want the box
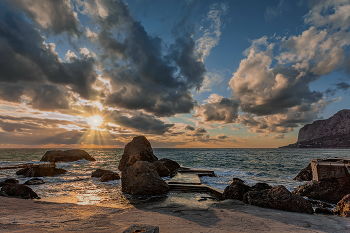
[122,161,169,195]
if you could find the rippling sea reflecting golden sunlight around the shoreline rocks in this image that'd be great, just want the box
[0,148,350,208]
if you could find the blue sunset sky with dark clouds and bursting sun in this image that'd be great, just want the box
[0,0,350,148]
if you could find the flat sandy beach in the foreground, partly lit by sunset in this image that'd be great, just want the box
[0,197,350,233]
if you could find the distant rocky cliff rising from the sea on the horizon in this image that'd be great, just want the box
[283,109,350,148]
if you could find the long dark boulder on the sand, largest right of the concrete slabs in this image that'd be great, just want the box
[243,185,313,214]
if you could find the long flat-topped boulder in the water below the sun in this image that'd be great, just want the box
[40,149,96,162]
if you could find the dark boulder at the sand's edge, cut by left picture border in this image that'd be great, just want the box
[1,184,40,199]
